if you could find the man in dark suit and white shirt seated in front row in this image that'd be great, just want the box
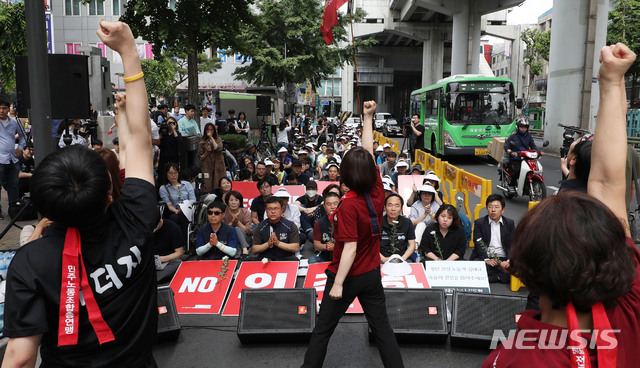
[469,194,515,284]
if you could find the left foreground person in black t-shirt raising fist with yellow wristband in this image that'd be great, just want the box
[3,20,159,367]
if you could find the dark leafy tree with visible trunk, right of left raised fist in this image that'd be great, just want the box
[120,0,253,105]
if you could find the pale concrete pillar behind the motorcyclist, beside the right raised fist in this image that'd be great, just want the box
[544,0,590,151]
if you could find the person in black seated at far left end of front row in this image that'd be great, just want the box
[153,219,184,282]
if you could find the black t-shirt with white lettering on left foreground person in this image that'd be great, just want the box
[4,178,159,367]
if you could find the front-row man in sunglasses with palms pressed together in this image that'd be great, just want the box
[196,201,238,260]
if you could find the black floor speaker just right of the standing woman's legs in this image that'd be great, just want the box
[369,288,449,344]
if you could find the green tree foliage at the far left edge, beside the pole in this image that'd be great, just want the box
[0,2,27,95]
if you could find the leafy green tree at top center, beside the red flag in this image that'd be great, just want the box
[234,0,375,109]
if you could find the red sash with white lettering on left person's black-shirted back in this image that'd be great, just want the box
[58,227,115,346]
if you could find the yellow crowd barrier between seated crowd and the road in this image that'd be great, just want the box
[413,150,492,247]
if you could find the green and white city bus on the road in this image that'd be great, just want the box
[411,75,515,156]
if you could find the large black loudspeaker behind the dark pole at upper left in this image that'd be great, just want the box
[16,54,91,119]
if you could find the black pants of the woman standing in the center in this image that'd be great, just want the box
[302,268,404,368]
